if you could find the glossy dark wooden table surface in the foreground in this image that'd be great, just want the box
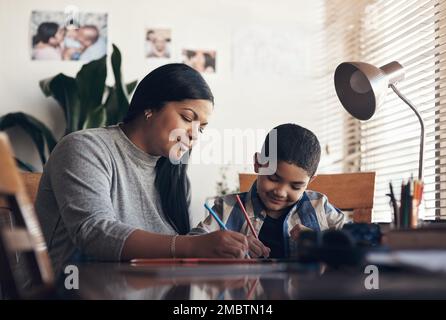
[68,262,446,300]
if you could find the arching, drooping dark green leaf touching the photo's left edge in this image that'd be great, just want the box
[0,112,56,164]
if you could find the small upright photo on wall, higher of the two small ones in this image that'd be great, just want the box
[145,29,171,59]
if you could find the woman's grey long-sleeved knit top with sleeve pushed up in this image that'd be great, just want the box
[36,125,176,273]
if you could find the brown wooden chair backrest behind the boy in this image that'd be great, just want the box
[239,172,375,223]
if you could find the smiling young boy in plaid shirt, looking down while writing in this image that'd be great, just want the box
[191,124,344,258]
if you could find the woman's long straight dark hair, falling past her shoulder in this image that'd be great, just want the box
[124,63,214,234]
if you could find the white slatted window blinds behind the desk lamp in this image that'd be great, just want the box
[321,0,446,222]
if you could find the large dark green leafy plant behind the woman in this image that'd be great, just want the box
[0,44,137,171]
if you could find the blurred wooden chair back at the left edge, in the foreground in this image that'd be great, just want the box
[0,133,54,299]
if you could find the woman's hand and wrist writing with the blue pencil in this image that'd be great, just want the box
[189,231,248,258]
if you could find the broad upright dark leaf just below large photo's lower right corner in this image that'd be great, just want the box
[76,55,107,129]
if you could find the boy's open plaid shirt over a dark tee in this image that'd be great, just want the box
[190,183,344,257]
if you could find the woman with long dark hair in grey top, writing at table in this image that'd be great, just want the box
[36,64,248,272]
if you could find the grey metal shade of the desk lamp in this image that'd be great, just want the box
[334,61,404,120]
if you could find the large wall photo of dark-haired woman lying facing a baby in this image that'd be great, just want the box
[30,11,107,62]
